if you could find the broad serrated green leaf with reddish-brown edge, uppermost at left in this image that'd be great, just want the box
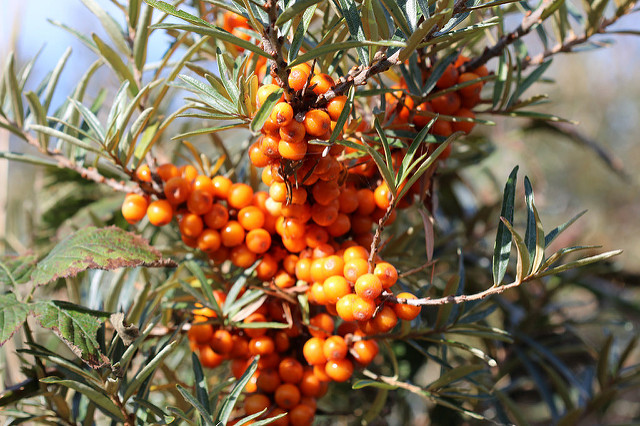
[31,226,176,285]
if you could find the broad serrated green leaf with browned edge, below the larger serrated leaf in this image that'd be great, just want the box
[34,300,109,368]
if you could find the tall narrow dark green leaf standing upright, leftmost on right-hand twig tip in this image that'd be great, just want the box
[493,166,519,286]
